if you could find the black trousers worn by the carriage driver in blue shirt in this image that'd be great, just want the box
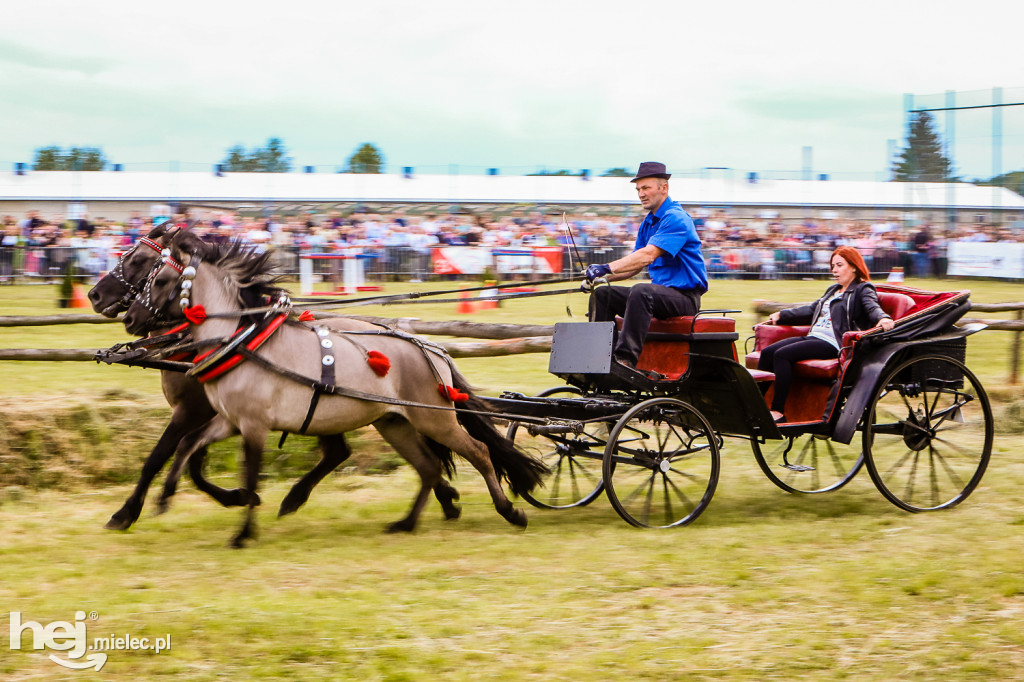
[590,282,700,367]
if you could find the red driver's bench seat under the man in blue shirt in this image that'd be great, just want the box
[615,311,739,381]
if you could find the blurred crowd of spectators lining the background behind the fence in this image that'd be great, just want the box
[0,205,1024,280]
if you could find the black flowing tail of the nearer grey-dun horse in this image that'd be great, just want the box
[452,367,549,496]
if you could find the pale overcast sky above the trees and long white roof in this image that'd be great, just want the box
[0,0,1024,179]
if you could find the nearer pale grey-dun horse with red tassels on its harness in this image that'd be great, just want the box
[118,230,547,547]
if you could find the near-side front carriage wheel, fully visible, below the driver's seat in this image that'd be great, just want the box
[602,398,720,528]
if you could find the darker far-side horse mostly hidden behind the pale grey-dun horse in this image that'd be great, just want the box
[88,223,462,530]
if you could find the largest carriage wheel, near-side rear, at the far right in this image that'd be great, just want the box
[863,355,993,512]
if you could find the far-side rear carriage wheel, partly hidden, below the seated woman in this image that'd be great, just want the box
[751,433,864,494]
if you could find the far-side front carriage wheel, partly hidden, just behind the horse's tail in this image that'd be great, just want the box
[508,386,608,509]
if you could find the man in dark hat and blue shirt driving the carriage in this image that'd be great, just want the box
[583,161,708,369]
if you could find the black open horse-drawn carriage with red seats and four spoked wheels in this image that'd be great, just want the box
[493,285,993,527]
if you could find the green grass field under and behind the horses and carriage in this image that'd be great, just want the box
[0,274,1024,680]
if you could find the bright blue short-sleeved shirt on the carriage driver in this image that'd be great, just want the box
[634,197,708,294]
